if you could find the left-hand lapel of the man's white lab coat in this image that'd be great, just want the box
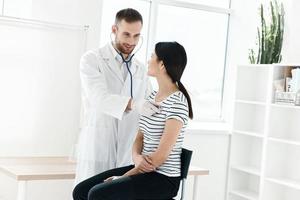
[100,45,124,83]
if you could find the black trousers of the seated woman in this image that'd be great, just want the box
[73,165,180,200]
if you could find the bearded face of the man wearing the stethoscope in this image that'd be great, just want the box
[112,20,142,55]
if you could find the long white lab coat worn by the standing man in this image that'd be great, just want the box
[75,44,152,183]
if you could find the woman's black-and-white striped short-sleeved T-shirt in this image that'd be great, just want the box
[139,91,189,177]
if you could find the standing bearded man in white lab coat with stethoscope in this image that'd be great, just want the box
[75,8,153,183]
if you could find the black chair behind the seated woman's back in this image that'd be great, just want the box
[180,148,193,200]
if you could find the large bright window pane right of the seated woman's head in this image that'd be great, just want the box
[155,5,228,120]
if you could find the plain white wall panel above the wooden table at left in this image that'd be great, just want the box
[0,22,85,156]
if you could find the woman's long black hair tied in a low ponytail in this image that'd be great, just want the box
[155,42,193,119]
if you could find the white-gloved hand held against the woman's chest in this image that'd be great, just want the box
[131,99,160,117]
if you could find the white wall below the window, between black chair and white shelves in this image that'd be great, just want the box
[184,129,230,200]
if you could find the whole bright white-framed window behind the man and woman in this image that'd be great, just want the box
[101,0,230,121]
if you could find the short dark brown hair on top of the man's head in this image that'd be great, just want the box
[115,8,143,24]
